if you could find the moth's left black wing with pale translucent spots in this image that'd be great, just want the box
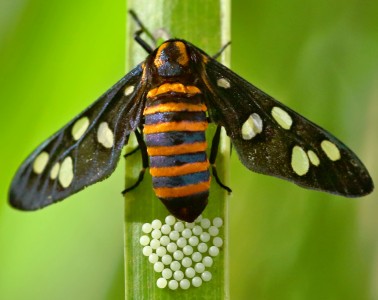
[9,65,145,210]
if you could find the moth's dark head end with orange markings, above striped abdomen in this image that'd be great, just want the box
[153,40,190,77]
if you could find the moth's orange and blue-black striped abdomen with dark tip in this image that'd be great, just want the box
[143,83,210,222]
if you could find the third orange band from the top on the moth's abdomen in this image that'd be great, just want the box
[143,121,207,134]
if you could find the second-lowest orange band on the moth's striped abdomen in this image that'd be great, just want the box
[150,160,210,177]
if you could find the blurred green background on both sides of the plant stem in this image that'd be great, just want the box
[0,0,378,300]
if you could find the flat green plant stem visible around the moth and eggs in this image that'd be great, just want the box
[125,0,230,299]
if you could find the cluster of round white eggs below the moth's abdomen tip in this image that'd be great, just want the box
[139,216,223,290]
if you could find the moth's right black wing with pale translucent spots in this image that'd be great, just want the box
[201,56,373,197]
